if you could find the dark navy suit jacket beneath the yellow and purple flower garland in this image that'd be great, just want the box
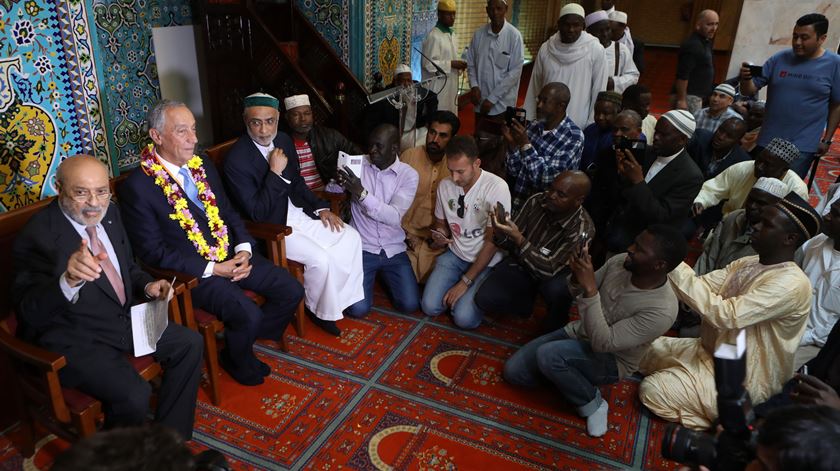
[117,158,256,278]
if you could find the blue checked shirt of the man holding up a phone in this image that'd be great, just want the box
[506,116,583,214]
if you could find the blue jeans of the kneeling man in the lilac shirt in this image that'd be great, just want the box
[344,250,420,317]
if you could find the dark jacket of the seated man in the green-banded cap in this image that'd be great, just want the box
[224,133,330,224]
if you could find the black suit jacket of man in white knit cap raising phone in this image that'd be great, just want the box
[613,149,703,238]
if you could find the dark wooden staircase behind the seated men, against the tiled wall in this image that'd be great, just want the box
[193,0,368,146]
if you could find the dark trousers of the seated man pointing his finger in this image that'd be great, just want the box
[55,324,204,440]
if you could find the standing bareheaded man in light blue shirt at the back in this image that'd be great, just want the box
[466,0,525,122]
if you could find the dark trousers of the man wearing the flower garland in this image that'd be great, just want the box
[192,254,303,374]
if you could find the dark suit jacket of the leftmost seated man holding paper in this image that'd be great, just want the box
[12,200,153,353]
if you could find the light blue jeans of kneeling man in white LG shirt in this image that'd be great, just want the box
[420,250,490,329]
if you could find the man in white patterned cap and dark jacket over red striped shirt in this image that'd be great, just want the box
[282,95,362,190]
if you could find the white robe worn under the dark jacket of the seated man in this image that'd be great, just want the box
[257,144,365,321]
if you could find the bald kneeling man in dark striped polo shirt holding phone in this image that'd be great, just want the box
[475,170,595,327]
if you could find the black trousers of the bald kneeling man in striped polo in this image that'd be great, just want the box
[475,257,573,326]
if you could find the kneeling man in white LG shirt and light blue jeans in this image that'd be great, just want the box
[421,136,510,329]
